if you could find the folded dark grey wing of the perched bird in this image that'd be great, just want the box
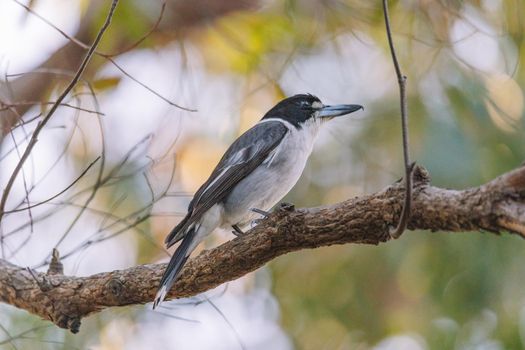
[165,121,288,247]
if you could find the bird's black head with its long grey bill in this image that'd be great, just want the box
[263,94,363,128]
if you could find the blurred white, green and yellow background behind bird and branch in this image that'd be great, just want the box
[0,0,525,350]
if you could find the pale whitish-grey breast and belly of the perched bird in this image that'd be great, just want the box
[221,121,316,228]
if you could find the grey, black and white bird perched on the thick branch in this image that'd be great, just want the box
[153,94,363,309]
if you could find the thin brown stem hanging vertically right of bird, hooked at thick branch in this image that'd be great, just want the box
[383,0,415,238]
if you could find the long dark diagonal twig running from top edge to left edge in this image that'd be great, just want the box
[0,0,118,252]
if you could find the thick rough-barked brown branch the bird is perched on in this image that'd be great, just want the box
[0,166,525,332]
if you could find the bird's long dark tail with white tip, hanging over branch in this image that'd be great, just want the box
[153,227,200,309]
